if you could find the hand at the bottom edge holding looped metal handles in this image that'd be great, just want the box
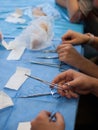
[31,111,65,130]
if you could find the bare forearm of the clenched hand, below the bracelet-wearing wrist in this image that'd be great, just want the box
[77,57,98,78]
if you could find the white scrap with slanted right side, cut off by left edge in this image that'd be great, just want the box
[0,91,14,109]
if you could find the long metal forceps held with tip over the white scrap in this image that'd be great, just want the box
[25,74,67,92]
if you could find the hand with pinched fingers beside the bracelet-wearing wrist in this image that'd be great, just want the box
[62,30,90,45]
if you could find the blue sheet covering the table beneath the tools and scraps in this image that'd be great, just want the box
[0,0,83,130]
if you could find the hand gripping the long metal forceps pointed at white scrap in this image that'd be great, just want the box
[52,69,98,98]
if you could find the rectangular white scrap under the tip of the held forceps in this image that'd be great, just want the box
[5,67,31,90]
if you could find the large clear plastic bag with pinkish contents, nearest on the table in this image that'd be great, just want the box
[10,17,53,50]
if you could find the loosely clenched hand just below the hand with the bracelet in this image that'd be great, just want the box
[56,44,84,69]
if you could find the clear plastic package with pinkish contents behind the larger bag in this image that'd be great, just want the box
[24,3,61,19]
